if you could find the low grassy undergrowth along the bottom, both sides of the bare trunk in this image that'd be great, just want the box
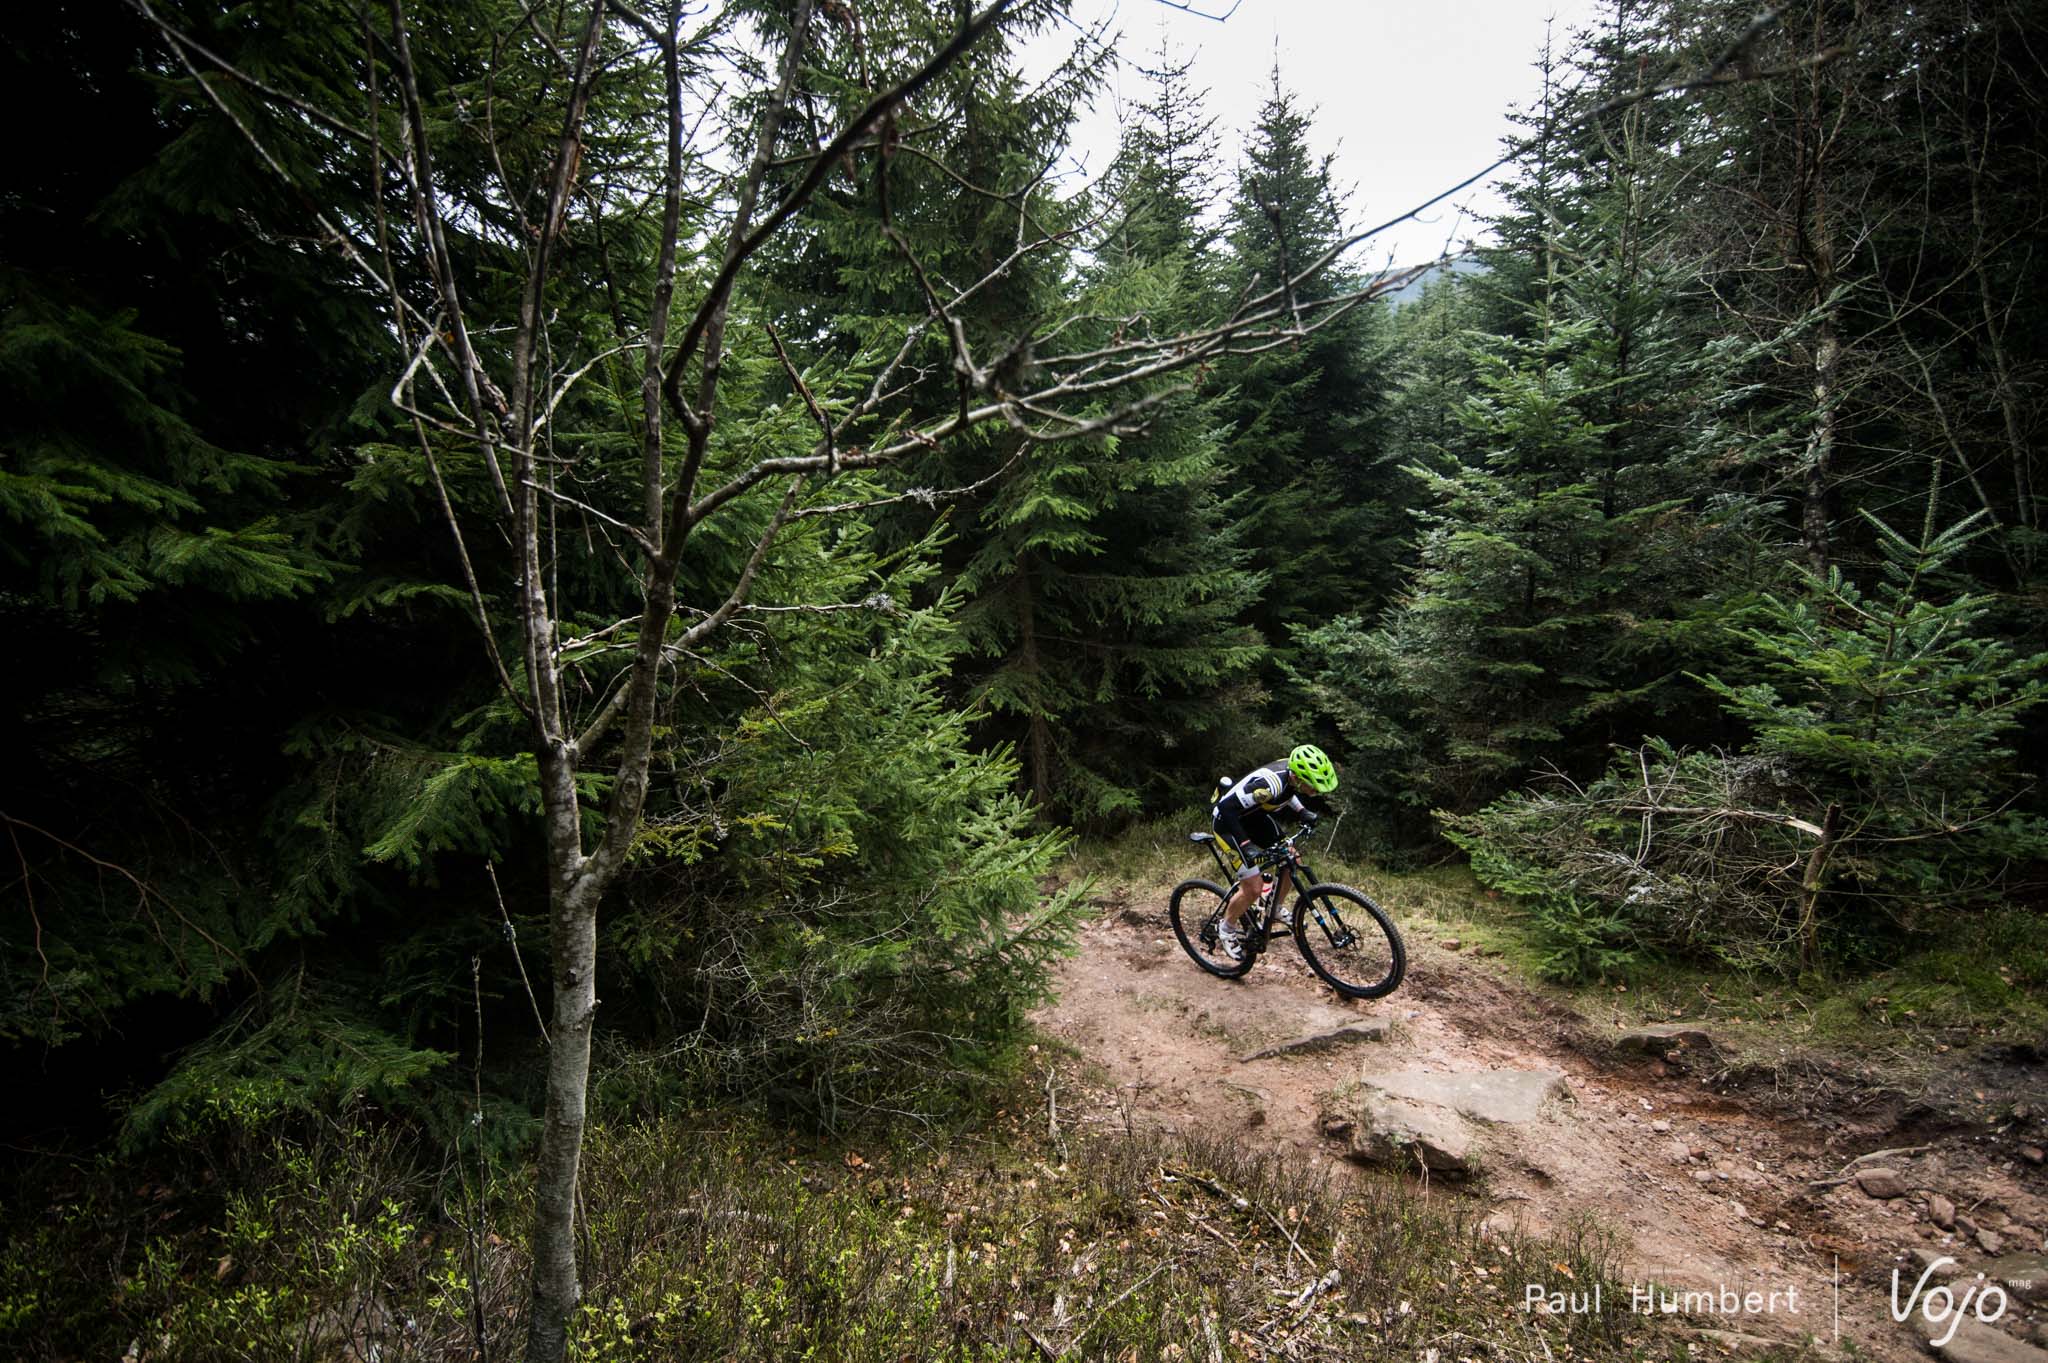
[0,1085,1681,1363]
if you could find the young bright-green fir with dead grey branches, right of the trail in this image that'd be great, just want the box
[1442,520,2048,976]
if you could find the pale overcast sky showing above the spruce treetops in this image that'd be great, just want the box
[1026,0,1597,266]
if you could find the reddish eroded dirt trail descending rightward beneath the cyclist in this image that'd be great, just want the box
[1036,886,2048,1363]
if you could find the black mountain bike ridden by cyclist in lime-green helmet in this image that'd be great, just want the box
[1167,825,1407,999]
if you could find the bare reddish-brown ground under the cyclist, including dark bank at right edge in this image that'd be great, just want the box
[1036,855,2048,1363]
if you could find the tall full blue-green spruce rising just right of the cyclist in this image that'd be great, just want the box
[1311,6,1739,810]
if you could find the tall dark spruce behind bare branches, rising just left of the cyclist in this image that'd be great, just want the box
[961,45,1262,825]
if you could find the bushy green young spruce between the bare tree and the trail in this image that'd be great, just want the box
[606,606,1085,1128]
